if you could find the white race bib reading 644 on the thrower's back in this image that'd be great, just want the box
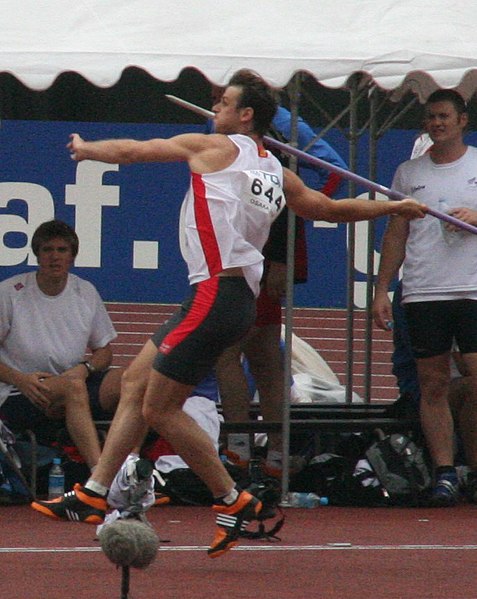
[242,170,284,218]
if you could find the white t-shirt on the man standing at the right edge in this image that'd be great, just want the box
[393,146,477,303]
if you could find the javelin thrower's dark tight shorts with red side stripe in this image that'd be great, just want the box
[152,276,256,385]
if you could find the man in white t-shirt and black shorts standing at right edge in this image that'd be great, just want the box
[373,90,477,506]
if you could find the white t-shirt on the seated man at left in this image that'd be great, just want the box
[0,272,117,405]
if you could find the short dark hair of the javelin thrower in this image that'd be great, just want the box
[228,69,278,135]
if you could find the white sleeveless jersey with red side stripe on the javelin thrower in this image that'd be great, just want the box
[180,135,285,295]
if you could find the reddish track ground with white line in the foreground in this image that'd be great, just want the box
[0,504,477,599]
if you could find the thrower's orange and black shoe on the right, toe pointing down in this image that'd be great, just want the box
[207,491,262,557]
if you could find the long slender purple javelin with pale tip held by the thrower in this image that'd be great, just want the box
[166,94,477,235]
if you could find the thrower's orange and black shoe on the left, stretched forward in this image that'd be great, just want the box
[31,483,108,524]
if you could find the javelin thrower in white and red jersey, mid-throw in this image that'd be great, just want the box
[32,71,427,558]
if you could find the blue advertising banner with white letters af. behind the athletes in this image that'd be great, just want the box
[0,121,450,307]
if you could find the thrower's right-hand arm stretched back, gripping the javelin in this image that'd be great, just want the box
[283,169,427,223]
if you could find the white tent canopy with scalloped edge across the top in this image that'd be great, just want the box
[5,0,477,99]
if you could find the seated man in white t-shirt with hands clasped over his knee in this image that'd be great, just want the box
[0,220,122,468]
